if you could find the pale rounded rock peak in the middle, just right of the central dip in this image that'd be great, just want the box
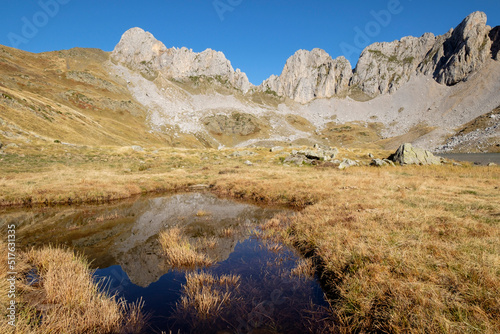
[260,49,352,103]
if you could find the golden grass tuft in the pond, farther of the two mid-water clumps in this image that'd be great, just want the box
[159,227,213,268]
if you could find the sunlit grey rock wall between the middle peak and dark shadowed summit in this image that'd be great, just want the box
[351,34,436,96]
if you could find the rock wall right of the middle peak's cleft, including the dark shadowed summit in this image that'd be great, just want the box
[351,12,499,97]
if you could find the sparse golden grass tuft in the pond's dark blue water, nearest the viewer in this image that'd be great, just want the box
[177,272,240,319]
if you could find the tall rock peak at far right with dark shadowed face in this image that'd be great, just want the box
[433,12,491,86]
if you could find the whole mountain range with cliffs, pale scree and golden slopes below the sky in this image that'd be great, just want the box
[0,12,500,152]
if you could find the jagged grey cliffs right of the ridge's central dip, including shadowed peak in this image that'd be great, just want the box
[260,12,500,103]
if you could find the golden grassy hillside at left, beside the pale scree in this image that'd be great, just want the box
[0,46,175,145]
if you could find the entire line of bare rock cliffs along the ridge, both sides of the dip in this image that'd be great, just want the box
[111,12,500,103]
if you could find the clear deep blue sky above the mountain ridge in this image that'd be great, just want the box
[0,0,500,84]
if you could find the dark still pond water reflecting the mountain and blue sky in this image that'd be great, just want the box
[0,193,336,333]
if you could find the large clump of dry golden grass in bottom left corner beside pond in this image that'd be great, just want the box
[0,243,145,334]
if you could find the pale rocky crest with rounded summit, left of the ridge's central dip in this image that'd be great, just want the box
[111,28,251,92]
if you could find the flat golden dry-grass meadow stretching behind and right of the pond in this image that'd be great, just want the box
[0,144,500,333]
